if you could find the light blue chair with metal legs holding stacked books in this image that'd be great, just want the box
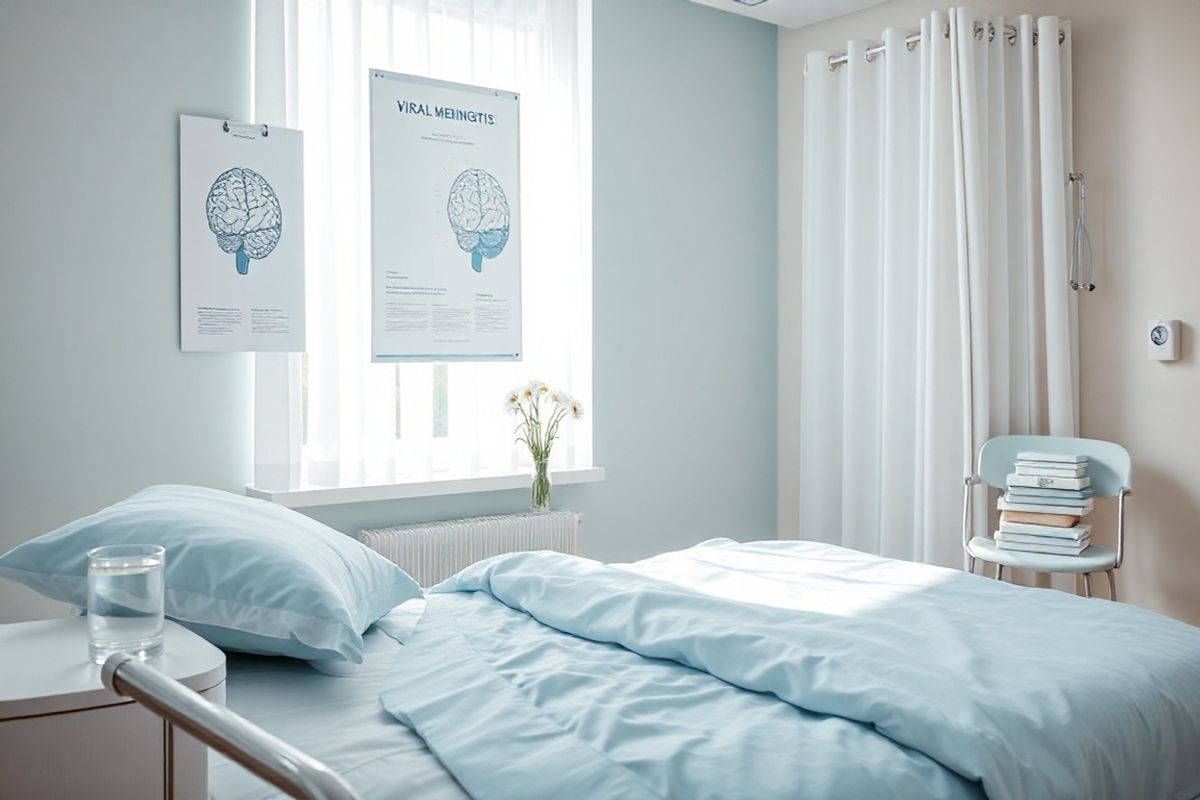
[962,437,1133,600]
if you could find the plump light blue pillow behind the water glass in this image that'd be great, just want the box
[0,486,421,663]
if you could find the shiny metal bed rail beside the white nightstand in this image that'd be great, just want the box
[101,654,358,800]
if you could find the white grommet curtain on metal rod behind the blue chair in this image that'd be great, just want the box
[799,8,1078,566]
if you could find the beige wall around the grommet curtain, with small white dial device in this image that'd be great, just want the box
[779,0,1200,625]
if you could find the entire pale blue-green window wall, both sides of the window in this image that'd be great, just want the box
[0,0,776,621]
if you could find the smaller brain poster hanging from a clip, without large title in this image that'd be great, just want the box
[179,115,305,353]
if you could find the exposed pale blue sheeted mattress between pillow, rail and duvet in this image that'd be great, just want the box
[209,601,467,800]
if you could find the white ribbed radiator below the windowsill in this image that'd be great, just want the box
[358,511,581,587]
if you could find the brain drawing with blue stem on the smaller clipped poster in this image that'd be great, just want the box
[204,167,283,275]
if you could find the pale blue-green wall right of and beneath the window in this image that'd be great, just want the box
[311,0,776,560]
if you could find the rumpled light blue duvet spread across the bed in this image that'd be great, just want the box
[382,540,1200,800]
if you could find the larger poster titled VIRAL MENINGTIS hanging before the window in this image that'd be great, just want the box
[370,70,521,361]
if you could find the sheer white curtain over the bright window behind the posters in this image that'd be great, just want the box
[254,0,592,487]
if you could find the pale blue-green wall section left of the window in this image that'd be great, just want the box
[0,0,253,622]
